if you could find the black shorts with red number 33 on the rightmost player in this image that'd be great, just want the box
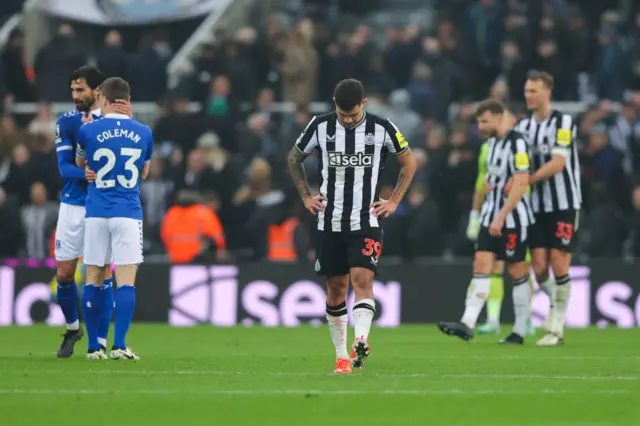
[529,210,580,253]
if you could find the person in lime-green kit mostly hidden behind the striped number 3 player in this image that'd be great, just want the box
[467,111,536,336]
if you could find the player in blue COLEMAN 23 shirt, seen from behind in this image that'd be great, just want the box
[76,78,153,360]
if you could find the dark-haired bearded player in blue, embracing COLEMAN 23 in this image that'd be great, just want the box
[54,66,131,358]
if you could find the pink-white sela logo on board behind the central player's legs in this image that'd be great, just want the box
[169,265,401,327]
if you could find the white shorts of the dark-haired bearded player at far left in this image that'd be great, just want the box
[55,203,85,260]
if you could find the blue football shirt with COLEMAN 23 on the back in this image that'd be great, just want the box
[77,114,153,220]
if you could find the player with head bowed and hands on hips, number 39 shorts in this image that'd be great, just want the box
[288,80,416,374]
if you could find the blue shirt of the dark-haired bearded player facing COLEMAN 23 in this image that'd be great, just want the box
[55,109,100,206]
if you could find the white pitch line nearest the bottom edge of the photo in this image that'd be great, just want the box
[0,388,632,396]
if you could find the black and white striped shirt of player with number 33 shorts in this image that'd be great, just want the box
[516,110,582,214]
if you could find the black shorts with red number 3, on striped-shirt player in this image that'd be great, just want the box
[476,226,529,263]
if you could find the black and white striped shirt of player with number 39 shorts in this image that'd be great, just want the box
[295,112,409,232]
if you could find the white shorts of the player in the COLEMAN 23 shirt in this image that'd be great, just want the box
[84,217,144,266]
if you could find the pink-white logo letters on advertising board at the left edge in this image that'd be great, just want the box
[0,266,65,326]
